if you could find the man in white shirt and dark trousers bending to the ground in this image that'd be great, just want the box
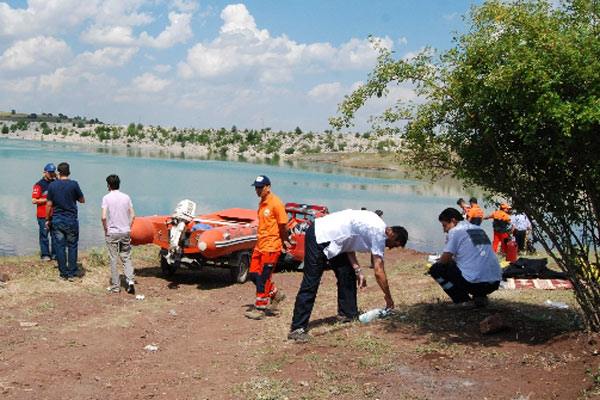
[288,210,408,340]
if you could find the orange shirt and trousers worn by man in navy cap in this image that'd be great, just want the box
[249,193,288,310]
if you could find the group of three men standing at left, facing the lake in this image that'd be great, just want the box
[31,162,135,294]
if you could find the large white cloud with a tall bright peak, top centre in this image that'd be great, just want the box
[178,4,393,83]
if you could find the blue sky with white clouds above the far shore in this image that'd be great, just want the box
[0,0,482,132]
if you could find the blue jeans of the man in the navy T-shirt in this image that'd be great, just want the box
[50,221,79,278]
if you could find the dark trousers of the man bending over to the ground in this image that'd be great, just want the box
[292,225,358,330]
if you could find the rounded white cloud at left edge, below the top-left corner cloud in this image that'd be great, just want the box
[0,36,71,71]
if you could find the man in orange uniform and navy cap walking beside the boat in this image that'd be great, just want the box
[245,175,288,320]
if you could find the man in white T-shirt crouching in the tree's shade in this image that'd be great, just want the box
[429,208,502,307]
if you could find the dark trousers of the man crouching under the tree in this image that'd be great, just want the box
[429,263,500,303]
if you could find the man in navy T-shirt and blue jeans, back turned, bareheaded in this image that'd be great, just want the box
[46,162,85,281]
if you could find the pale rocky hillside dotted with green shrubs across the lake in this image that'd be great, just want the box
[0,120,400,158]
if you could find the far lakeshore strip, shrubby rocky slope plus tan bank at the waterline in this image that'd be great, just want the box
[0,121,404,171]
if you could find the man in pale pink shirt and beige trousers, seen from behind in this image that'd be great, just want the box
[102,175,135,294]
